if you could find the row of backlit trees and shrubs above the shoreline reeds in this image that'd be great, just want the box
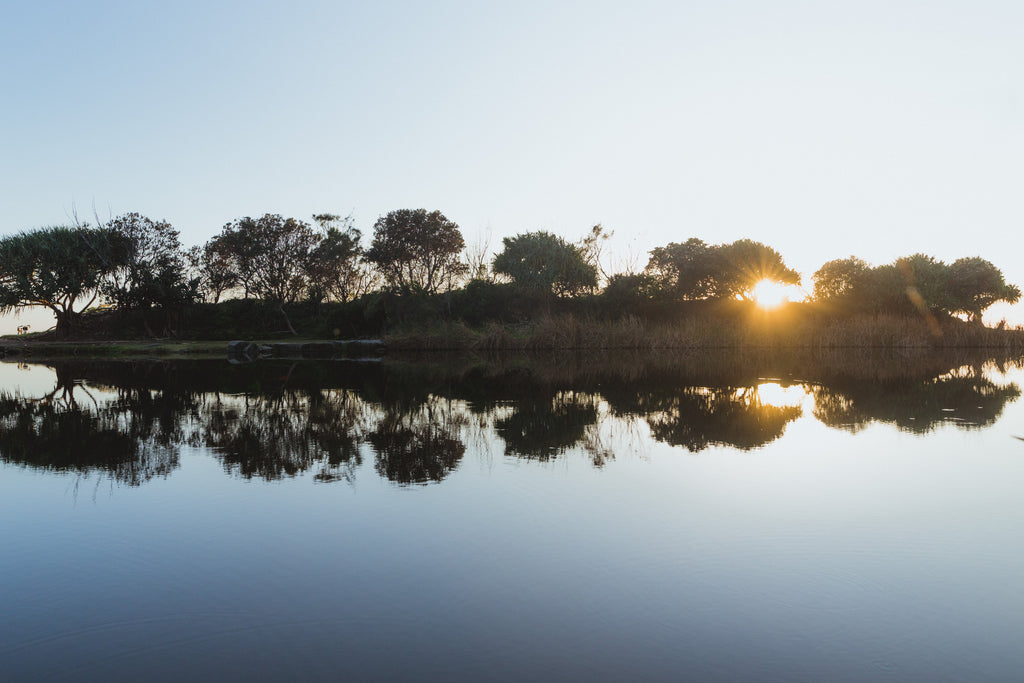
[0,209,1021,338]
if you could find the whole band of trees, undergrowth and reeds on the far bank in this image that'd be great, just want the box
[0,209,1021,347]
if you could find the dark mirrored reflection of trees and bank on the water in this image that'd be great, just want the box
[0,353,1021,485]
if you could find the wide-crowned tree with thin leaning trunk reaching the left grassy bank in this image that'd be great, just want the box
[215,213,319,334]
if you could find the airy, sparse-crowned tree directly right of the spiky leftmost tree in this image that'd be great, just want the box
[100,213,199,309]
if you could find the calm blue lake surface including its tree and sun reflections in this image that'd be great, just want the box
[0,352,1024,681]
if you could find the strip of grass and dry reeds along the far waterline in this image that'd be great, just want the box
[8,302,1024,357]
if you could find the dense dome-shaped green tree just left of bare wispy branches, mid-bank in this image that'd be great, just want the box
[493,230,597,296]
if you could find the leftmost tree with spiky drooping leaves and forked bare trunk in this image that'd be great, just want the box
[0,226,121,338]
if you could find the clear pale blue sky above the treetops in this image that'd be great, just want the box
[0,0,1024,333]
